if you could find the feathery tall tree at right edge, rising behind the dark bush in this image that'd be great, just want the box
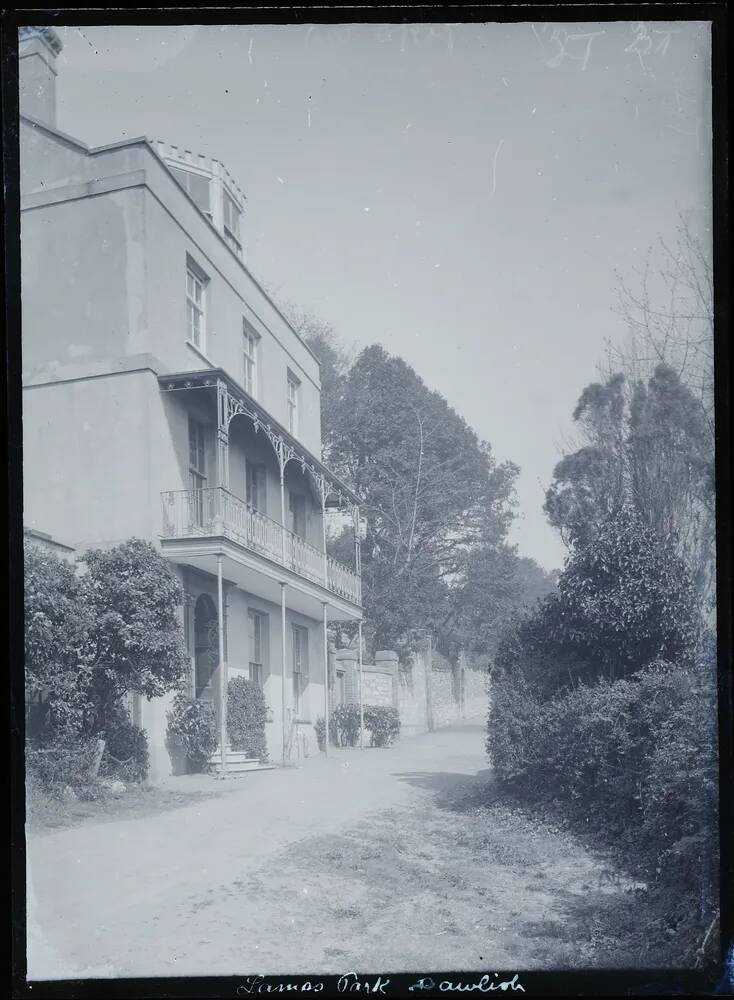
[544,364,715,607]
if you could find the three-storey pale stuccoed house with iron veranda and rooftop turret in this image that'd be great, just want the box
[19,28,362,779]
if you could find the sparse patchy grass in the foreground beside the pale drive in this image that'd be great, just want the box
[200,795,660,975]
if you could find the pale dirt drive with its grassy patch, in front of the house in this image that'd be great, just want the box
[23,724,632,979]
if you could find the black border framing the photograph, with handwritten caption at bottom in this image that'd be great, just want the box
[0,2,734,998]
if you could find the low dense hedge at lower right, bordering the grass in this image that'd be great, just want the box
[487,661,718,960]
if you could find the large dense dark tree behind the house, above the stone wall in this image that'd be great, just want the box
[329,345,517,645]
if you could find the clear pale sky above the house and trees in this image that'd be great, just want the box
[51,21,711,569]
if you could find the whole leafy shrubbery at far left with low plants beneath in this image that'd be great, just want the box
[24,539,186,789]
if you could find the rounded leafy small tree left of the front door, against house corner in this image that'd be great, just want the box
[80,538,186,727]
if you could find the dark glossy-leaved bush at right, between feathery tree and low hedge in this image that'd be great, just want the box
[495,506,699,699]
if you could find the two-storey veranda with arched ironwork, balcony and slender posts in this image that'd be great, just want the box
[159,370,362,775]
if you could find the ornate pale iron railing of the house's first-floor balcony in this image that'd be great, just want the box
[161,486,361,605]
